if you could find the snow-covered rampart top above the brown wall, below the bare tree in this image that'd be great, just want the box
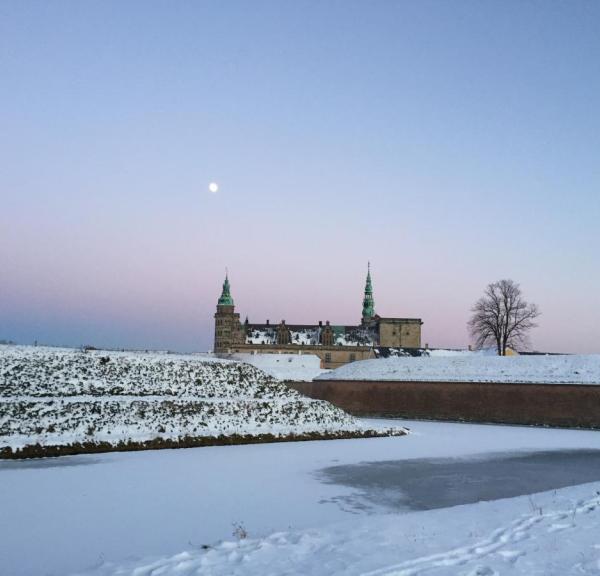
[317,354,600,384]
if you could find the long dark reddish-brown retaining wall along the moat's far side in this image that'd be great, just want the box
[291,380,600,428]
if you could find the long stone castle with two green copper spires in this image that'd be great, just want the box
[214,266,423,368]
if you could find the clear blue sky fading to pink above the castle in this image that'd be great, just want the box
[0,0,600,353]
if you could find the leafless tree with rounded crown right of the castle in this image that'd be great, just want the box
[468,280,540,356]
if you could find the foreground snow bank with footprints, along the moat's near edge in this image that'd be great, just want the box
[68,483,600,576]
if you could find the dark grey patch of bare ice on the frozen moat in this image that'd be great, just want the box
[316,450,600,511]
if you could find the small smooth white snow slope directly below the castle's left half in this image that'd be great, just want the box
[232,354,330,382]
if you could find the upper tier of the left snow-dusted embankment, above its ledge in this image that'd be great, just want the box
[0,346,289,398]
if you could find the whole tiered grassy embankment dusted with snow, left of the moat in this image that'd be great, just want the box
[0,346,400,450]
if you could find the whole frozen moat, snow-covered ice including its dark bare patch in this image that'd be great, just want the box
[0,421,600,576]
